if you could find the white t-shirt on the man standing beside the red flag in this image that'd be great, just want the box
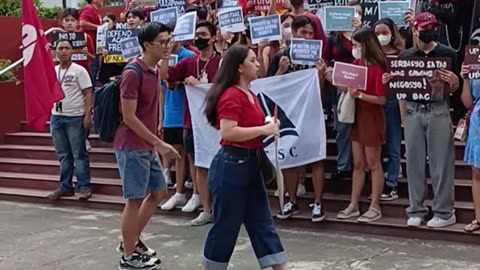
[52,63,92,116]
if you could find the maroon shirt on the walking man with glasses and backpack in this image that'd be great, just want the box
[113,58,160,151]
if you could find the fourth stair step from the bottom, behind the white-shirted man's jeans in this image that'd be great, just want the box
[0,144,115,162]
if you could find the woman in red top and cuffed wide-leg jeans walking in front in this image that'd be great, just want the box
[203,45,287,270]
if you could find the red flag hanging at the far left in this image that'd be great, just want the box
[22,0,65,131]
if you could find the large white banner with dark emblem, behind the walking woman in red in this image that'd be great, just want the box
[186,69,327,169]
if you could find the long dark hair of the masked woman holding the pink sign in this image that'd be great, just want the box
[352,27,386,70]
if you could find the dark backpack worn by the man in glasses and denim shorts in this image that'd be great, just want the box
[93,63,143,143]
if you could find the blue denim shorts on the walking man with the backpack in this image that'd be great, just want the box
[115,149,167,199]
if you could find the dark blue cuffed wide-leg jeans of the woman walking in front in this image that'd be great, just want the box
[203,147,286,270]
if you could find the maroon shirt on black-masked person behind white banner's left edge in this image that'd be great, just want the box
[168,53,222,129]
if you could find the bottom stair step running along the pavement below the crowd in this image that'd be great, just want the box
[0,187,480,245]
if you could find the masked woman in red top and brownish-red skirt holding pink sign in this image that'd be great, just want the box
[337,28,386,222]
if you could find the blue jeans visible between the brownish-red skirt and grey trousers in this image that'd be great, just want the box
[383,99,402,188]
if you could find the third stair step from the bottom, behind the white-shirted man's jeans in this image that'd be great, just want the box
[0,158,120,179]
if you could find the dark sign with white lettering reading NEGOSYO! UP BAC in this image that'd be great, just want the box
[386,57,452,101]
